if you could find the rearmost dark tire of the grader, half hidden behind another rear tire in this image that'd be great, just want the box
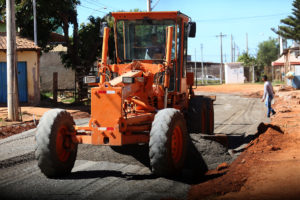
[203,98,215,135]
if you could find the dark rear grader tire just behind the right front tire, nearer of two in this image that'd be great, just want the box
[186,96,207,133]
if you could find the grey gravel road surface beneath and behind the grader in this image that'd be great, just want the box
[0,94,267,199]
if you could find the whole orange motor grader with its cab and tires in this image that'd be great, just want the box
[35,11,214,177]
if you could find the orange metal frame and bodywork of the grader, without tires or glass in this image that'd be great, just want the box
[75,12,193,145]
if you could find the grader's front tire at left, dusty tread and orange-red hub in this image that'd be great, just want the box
[35,109,78,177]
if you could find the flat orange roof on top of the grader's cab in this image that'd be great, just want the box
[111,11,189,22]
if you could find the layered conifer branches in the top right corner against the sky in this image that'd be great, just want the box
[272,0,300,42]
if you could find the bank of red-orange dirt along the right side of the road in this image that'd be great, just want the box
[188,87,300,200]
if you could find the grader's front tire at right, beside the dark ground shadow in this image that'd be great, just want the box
[149,108,188,176]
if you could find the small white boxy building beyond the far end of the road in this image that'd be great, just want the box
[224,62,245,84]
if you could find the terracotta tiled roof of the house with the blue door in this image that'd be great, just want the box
[0,33,41,51]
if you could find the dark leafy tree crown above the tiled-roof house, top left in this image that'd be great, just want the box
[0,0,80,51]
